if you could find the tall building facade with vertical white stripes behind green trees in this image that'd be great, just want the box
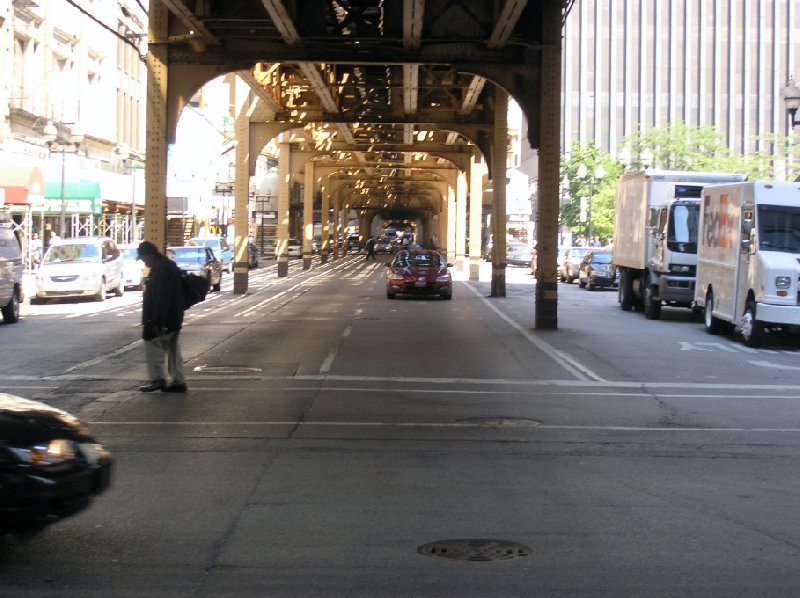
[561,0,800,162]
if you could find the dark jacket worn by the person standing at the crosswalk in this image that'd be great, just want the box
[142,254,185,341]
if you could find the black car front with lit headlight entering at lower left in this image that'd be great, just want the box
[0,393,113,533]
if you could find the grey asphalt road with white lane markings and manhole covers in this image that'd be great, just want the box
[0,256,800,598]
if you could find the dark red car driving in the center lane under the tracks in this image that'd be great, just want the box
[386,249,453,299]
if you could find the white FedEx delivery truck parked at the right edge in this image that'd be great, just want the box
[695,181,800,347]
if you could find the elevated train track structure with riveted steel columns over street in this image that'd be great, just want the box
[145,0,572,328]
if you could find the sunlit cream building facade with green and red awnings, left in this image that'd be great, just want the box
[0,0,147,265]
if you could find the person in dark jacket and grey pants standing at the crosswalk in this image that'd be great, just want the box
[138,241,186,392]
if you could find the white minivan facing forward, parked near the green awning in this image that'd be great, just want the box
[34,237,125,301]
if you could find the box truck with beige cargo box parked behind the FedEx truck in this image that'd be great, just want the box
[613,169,747,320]
